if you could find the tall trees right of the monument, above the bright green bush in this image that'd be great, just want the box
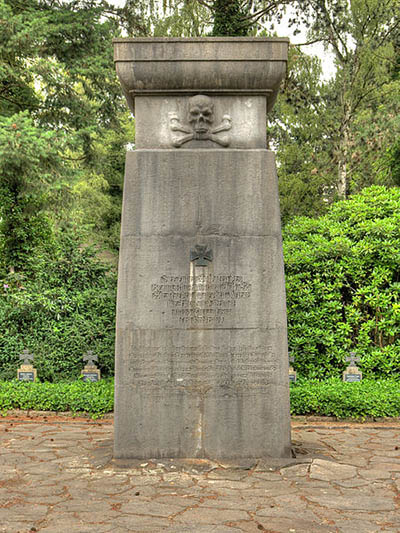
[269,0,400,216]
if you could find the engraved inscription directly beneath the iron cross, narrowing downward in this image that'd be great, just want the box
[151,274,251,326]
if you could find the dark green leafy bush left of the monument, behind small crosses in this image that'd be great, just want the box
[0,231,116,382]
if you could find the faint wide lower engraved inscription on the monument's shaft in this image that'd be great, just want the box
[127,346,277,386]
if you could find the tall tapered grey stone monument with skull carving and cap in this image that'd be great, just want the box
[114,38,290,459]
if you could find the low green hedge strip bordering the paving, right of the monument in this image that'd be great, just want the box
[290,378,400,418]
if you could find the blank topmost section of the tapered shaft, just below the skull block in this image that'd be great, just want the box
[121,149,280,240]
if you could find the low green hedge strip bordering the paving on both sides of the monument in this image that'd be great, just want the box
[0,378,400,419]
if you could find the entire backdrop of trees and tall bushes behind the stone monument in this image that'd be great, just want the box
[0,0,400,390]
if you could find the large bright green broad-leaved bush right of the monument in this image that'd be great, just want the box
[284,187,400,379]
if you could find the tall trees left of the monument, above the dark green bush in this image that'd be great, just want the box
[0,0,136,260]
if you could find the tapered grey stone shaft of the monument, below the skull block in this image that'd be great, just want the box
[115,150,290,459]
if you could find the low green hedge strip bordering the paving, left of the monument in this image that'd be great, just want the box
[0,379,114,418]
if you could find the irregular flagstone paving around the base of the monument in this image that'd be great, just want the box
[0,416,400,533]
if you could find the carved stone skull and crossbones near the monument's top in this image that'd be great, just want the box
[170,94,232,148]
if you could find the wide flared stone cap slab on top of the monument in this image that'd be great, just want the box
[113,37,289,111]
